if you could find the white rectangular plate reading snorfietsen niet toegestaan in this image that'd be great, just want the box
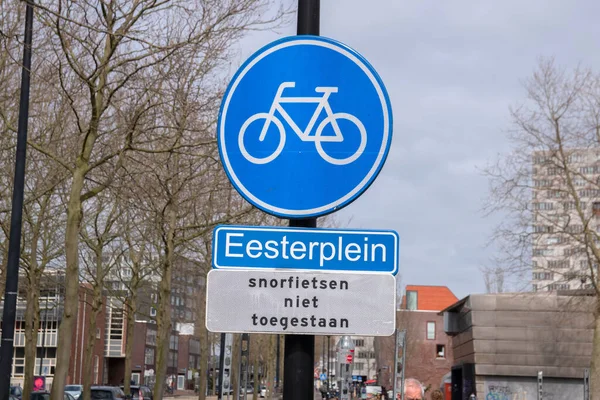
[206,269,396,336]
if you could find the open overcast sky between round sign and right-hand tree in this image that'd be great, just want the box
[231,0,600,297]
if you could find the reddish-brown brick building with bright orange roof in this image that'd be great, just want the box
[375,285,458,388]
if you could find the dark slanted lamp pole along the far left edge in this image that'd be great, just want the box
[0,0,33,400]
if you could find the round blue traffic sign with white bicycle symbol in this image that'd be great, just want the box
[217,36,392,218]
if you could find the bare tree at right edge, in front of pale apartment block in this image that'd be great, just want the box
[486,60,600,399]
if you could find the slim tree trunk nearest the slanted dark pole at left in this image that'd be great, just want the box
[22,267,45,400]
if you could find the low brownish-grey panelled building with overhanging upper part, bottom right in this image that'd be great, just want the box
[441,291,596,400]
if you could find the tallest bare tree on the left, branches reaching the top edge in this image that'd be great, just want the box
[18,0,288,400]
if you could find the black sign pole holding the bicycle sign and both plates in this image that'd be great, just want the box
[283,0,321,400]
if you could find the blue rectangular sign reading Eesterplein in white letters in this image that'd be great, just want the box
[213,225,400,275]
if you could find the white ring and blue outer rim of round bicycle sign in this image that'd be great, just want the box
[217,35,392,218]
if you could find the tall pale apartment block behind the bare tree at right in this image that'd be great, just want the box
[529,148,600,291]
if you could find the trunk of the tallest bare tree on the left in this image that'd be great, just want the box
[51,166,85,400]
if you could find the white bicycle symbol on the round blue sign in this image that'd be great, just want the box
[238,82,367,165]
